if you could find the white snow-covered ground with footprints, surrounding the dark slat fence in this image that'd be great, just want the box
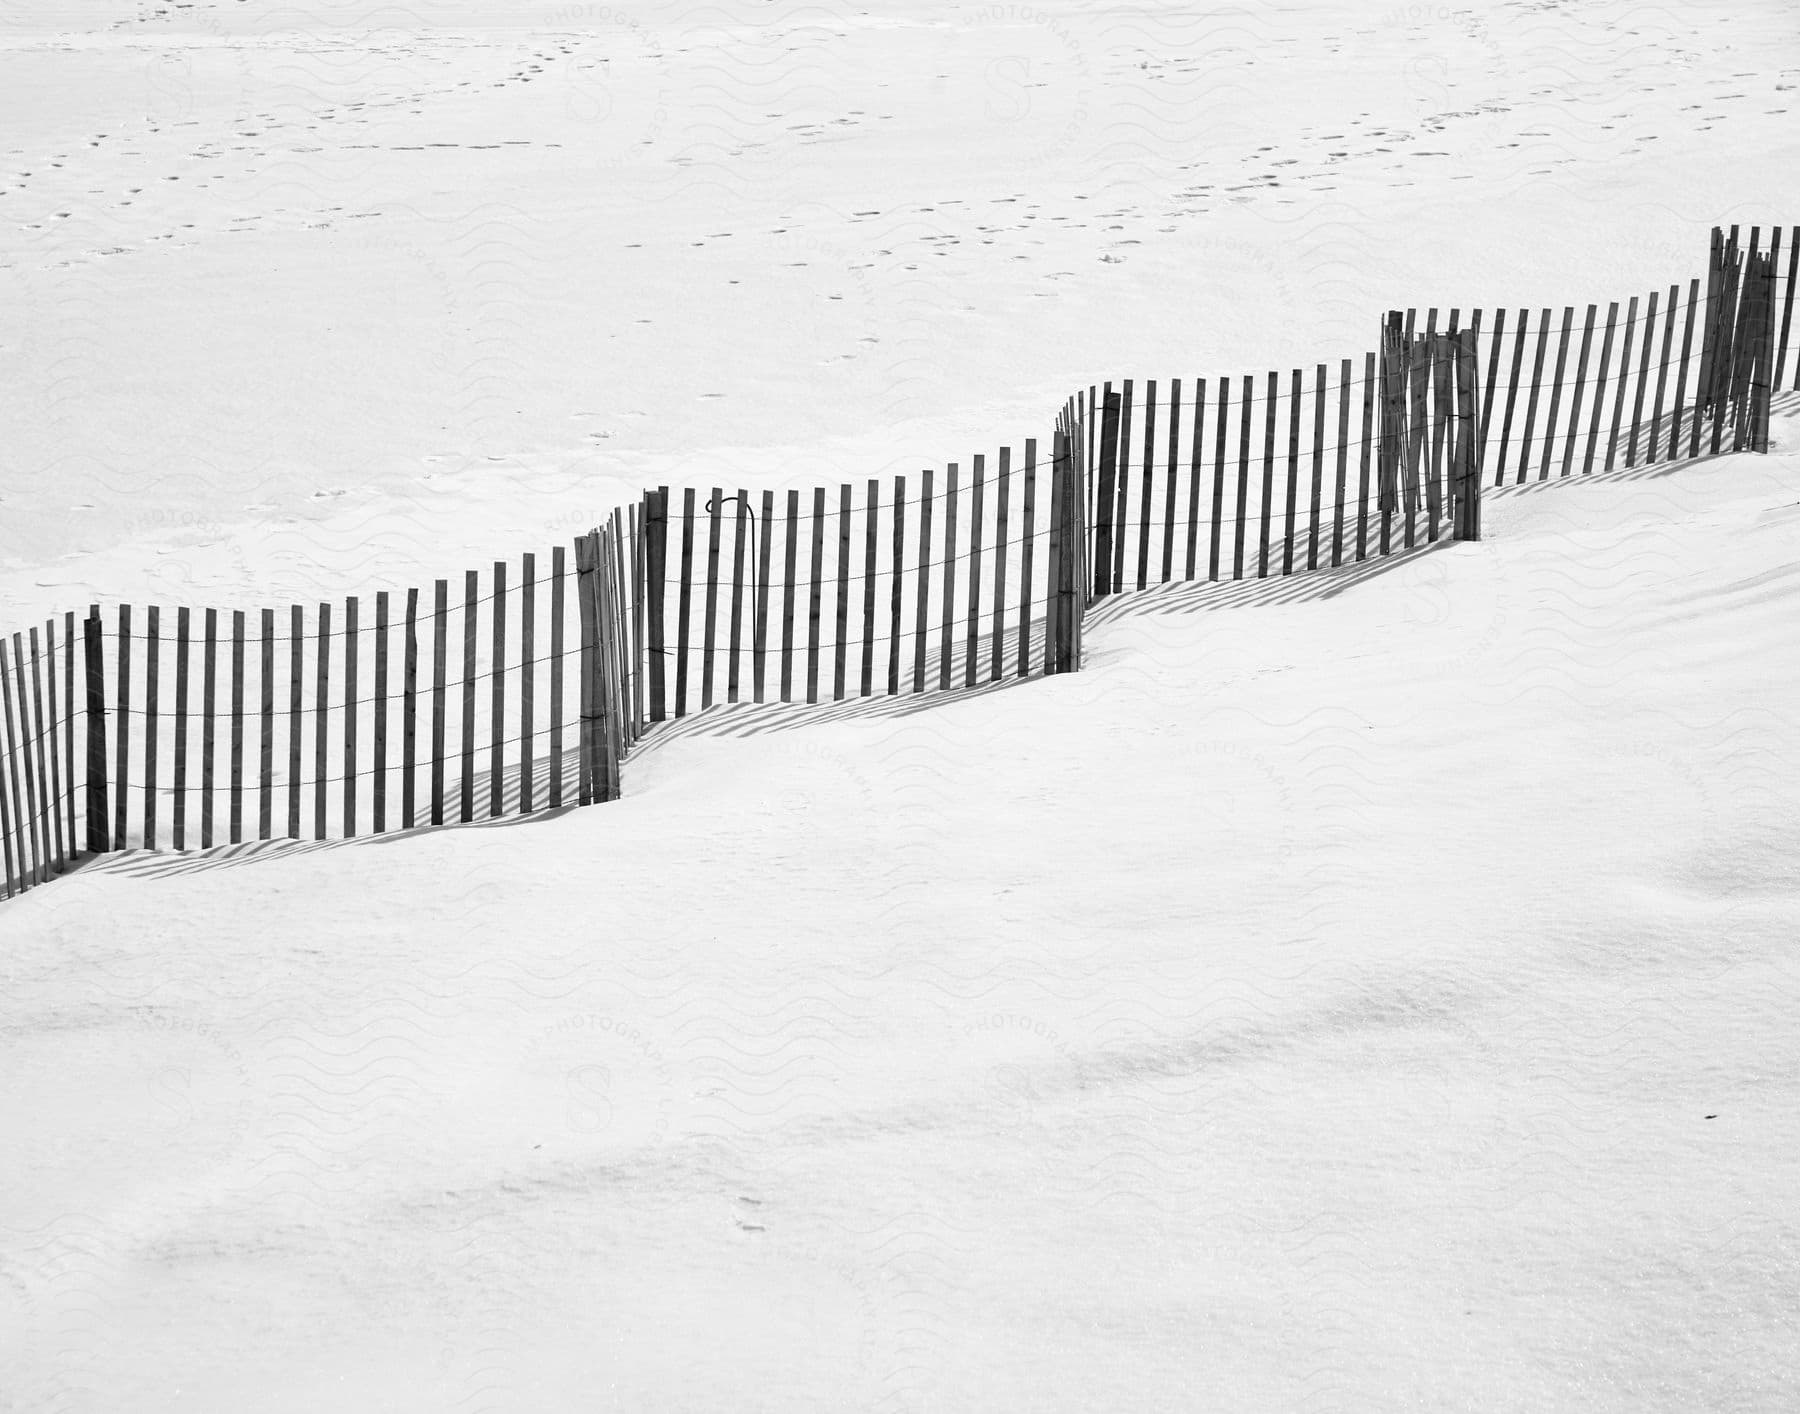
[0,0,1800,1412]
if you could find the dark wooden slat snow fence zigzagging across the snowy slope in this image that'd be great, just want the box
[0,227,1800,896]
